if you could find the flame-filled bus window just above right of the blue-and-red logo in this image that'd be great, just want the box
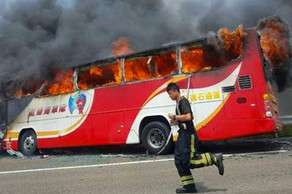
[77,63,122,90]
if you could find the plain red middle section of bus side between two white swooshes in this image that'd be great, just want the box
[39,80,171,148]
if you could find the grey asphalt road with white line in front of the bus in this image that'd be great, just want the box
[0,139,292,194]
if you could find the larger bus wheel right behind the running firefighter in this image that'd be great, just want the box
[141,121,173,154]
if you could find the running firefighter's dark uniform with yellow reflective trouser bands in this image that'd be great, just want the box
[174,97,223,190]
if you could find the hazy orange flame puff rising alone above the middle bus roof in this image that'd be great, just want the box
[112,37,133,56]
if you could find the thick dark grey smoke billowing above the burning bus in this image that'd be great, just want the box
[0,0,292,97]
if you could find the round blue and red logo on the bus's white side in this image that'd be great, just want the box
[68,92,86,114]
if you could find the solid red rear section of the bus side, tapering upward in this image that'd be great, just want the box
[198,29,276,140]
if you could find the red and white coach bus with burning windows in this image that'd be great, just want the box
[2,29,281,155]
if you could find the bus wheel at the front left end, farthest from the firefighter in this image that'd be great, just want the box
[19,130,37,156]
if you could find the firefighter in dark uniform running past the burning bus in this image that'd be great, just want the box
[166,83,224,193]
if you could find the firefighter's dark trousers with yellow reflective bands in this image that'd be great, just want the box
[174,131,216,188]
